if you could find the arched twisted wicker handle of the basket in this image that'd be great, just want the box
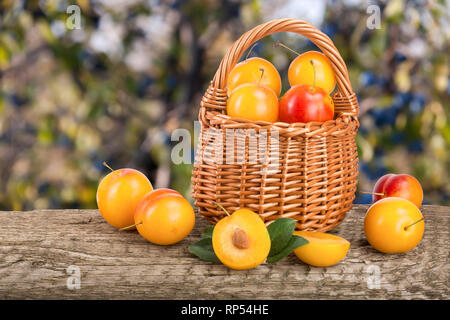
[212,18,353,97]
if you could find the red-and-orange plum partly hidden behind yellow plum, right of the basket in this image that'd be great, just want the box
[372,173,423,208]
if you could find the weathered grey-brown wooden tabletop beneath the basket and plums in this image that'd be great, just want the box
[0,205,450,299]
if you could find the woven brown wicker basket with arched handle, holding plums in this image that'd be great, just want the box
[192,19,359,231]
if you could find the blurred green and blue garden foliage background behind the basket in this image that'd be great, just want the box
[0,0,450,210]
